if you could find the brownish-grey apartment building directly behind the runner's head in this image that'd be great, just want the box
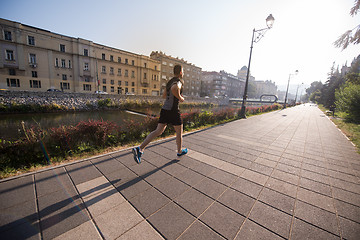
[150,51,201,97]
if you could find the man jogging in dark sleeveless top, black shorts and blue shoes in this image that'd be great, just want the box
[132,65,188,163]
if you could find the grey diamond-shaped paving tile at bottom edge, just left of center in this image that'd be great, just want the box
[148,203,195,240]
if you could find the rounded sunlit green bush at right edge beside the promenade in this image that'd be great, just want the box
[335,82,360,123]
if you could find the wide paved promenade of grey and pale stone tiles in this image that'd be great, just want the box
[0,105,360,240]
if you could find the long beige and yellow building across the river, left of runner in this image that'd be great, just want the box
[0,19,161,96]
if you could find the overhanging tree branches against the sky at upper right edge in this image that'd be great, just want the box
[334,0,360,50]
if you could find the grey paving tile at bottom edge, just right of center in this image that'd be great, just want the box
[200,202,245,239]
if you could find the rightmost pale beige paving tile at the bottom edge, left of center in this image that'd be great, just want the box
[94,202,143,239]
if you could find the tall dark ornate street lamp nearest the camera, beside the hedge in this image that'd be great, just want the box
[240,14,275,118]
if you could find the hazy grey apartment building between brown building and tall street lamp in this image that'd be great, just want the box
[201,71,245,98]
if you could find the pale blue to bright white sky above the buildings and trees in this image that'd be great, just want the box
[0,0,360,91]
